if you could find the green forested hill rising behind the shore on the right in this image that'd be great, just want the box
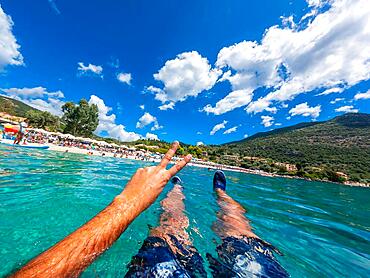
[220,113,370,183]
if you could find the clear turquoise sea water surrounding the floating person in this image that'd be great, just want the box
[0,146,370,277]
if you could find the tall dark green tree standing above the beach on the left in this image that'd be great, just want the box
[62,99,99,137]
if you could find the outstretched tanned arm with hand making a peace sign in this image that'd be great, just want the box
[14,142,191,277]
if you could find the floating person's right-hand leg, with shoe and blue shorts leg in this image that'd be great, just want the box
[207,171,289,277]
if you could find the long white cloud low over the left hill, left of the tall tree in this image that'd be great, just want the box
[0,86,64,116]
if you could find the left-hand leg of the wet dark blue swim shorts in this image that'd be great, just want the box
[125,236,207,278]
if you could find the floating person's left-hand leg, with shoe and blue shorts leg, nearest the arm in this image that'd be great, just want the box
[126,177,206,277]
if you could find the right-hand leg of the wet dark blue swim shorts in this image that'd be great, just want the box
[207,237,289,277]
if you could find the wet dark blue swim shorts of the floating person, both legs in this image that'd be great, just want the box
[125,236,289,278]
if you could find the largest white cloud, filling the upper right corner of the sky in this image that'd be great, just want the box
[216,0,370,113]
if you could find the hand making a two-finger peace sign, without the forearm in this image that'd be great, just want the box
[118,141,191,210]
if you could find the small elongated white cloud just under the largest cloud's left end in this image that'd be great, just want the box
[202,90,253,115]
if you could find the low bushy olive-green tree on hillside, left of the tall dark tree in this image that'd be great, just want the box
[26,110,60,131]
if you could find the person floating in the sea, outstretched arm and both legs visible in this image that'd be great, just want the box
[13,142,288,277]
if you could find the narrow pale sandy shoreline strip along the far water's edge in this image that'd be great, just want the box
[47,144,370,188]
